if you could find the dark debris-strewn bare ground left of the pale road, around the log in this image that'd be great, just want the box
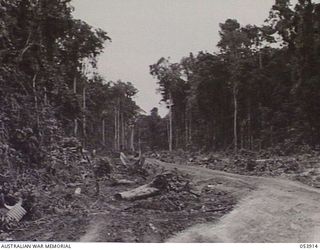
[4,159,236,242]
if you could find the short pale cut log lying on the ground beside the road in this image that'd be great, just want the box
[114,184,160,201]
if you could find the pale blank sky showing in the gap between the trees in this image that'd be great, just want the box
[72,0,275,115]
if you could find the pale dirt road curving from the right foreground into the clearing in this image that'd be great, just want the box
[147,159,320,243]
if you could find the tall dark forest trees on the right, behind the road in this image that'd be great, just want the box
[150,0,320,153]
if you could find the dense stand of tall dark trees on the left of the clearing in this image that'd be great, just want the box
[0,0,138,169]
